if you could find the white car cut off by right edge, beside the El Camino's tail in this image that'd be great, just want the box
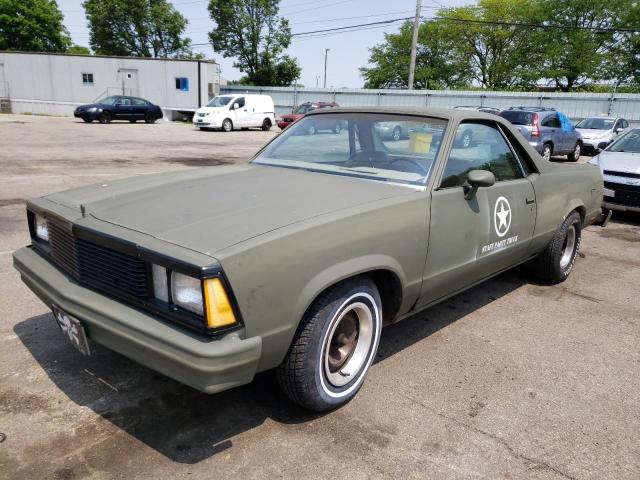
[589,128,640,213]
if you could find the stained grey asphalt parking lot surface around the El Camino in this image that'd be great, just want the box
[0,115,640,480]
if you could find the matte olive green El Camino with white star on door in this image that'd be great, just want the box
[14,108,603,411]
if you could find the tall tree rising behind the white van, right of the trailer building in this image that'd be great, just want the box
[208,0,300,86]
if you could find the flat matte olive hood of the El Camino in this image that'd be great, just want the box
[46,164,416,256]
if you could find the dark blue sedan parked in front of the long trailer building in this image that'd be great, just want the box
[73,95,163,123]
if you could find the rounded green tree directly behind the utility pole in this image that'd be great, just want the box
[360,21,469,89]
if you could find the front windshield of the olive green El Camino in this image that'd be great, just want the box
[253,113,447,185]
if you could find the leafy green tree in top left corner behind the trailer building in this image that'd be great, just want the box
[0,0,71,52]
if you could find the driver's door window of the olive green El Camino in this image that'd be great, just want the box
[440,123,523,188]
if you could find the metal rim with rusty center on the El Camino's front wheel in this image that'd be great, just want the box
[324,302,373,387]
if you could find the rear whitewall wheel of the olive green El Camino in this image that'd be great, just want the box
[535,211,582,283]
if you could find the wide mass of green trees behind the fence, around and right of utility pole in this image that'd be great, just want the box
[360,0,640,91]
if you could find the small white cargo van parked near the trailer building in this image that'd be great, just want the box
[193,95,276,132]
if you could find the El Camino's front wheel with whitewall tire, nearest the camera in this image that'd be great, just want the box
[277,277,382,412]
